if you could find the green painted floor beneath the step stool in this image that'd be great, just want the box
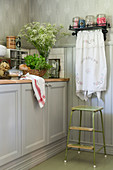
[31,150,113,170]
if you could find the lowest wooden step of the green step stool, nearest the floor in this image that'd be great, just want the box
[67,144,94,150]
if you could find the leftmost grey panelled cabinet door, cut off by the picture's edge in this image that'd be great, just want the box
[0,84,21,166]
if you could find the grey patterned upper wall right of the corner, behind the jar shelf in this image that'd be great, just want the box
[30,0,113,44]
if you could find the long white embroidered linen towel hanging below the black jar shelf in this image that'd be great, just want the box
[75,30,107,101]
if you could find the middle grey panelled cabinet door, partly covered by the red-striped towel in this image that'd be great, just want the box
[22,84,47,155]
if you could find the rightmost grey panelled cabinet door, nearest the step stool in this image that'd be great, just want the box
[48,82,67,143]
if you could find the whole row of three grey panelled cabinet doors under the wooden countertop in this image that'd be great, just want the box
[0,82,67,166]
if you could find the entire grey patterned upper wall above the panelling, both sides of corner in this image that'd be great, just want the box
[0,0,113,47]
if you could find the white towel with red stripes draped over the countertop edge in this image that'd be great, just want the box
[21,73,45,108]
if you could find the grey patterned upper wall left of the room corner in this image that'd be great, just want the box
[0,0,29,44]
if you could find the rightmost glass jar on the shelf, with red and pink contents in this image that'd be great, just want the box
[97,14,106,26]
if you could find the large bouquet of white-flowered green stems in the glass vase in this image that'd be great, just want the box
[18,22,69,59]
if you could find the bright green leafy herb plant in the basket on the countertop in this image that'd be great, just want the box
[24,54,51,71]
